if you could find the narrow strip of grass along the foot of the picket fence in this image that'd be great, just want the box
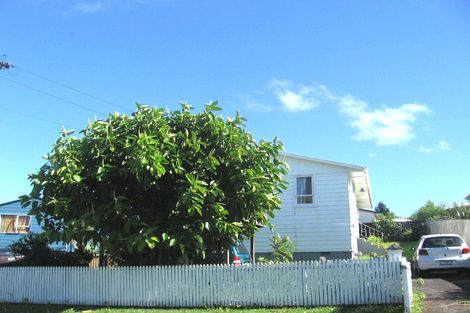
[0,304,404,313]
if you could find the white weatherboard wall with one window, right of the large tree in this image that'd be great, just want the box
[256,156,357,260]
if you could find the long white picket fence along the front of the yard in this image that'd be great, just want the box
[0,258,411,307]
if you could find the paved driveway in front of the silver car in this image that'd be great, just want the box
[413,274,470,313]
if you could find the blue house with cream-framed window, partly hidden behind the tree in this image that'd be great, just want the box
[0,200,66,251]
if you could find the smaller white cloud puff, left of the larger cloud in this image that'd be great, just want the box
[272,79,320,112]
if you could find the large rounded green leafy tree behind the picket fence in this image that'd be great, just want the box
[23,103,287,264]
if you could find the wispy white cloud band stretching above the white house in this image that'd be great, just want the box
[243,79,434,149]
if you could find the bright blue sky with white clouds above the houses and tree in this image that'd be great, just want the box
[0,0,470,216]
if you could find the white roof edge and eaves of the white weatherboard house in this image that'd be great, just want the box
[280,152,373,209]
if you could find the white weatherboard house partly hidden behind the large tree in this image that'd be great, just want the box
[256,153,373,260]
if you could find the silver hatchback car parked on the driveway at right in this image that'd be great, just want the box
[413,234,470,276]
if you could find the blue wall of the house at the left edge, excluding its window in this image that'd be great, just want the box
[0,201,66,249]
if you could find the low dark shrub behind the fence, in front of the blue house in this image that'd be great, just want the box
[8,234,92,266]
